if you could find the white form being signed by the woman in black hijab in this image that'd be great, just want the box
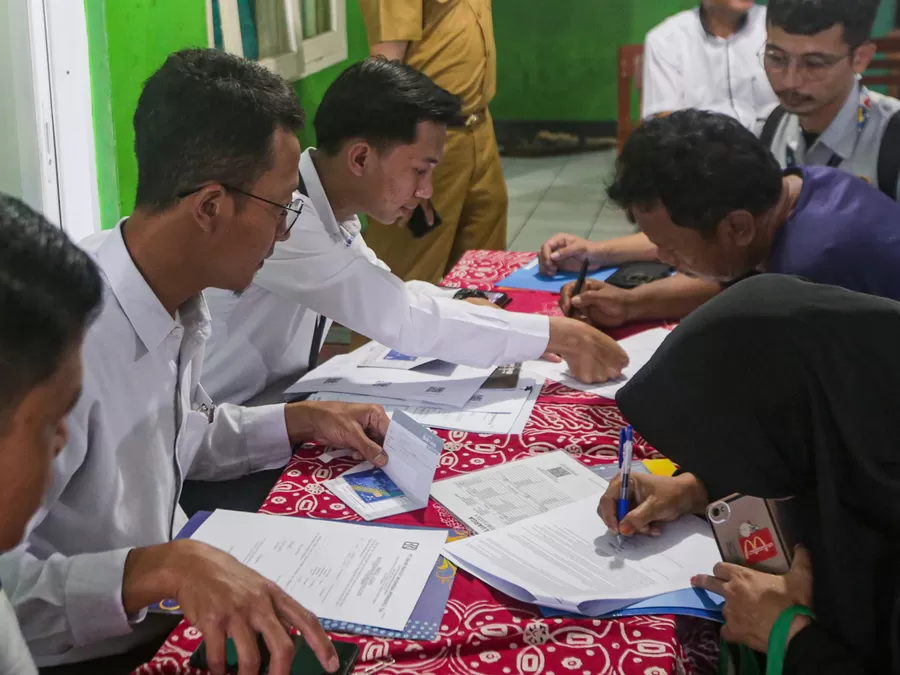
[444,495,721,616]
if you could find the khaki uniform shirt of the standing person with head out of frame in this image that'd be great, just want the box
[359,0,497,115]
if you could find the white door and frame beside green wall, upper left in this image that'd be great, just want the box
[0,0,100,241]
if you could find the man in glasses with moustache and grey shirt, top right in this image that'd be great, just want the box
[760,0,900,199]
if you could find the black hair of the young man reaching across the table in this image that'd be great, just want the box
[313,57,463,155]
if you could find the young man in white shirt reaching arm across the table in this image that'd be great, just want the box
[204,58,627,402]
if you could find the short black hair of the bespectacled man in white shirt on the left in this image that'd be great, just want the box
[134,49,304,211]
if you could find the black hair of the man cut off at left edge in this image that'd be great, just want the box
[0,194,103,424]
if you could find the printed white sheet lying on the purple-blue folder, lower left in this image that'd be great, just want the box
[191,511,447,630]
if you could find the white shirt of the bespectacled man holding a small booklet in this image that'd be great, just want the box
[0,224,291,666]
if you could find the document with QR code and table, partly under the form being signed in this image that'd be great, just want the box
[431,450,609,534]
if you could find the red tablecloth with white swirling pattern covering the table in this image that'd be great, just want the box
[136,251,718,675]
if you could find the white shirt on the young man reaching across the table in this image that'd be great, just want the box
[203,150,550,402]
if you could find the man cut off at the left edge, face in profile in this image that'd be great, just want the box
[0,194,103,675]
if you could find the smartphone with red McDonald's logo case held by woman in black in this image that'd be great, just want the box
[706,495,800,574]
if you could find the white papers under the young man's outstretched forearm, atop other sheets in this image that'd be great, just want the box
[285,342,494,408]
